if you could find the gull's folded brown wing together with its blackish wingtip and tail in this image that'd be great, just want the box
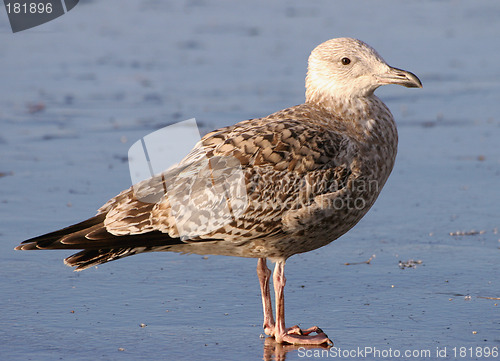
[17,105,357,270]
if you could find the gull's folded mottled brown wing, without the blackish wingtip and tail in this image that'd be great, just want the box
[100,105,357,241]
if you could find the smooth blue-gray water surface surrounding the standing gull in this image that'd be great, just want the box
[0,0,500,360]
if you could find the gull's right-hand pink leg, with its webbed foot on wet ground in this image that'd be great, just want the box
[273,260,333,345]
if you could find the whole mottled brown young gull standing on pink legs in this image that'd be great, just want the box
[16,38,422,345]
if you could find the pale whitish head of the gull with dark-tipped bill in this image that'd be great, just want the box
[306,38,422,105]
